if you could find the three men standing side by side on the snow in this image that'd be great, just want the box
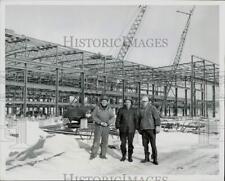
[90,96,160,165]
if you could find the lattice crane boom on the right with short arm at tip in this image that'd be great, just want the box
[160,6,195,115]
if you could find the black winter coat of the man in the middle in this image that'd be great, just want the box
[116,106,137,133]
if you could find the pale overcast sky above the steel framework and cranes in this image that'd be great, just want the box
[6,5,219,67]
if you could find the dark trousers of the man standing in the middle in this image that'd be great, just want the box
[120,131,134,155]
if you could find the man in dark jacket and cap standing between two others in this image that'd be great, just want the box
[116,97,137,162]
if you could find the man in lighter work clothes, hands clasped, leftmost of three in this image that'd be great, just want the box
[90,95,115,160]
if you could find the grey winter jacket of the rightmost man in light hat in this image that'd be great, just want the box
[138,103,160,130]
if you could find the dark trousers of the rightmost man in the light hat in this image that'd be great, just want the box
[142,129,157,159]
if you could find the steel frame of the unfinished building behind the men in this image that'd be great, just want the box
[5,29,219,117]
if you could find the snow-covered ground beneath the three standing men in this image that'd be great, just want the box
[6,119,219,180]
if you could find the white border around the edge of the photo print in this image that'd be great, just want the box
[0,0,225,181]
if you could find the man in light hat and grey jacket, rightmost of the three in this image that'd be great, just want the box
[137,96,160,165]
